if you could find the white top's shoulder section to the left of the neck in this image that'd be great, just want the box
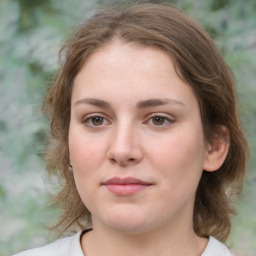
[13,232,84,256]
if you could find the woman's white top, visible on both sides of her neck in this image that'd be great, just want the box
[13,232,231,256]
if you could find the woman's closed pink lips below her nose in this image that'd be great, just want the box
[102,177,152,196]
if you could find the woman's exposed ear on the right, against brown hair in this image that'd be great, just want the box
[203,126,229,172]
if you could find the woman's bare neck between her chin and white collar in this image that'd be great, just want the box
[82,216,208,256]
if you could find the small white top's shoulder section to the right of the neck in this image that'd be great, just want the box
[201,236,232,256]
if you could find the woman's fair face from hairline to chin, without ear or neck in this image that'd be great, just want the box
[69,41,210,232]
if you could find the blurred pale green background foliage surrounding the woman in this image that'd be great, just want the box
[0,0,256,256]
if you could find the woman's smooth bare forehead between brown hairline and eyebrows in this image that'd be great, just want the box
[73,41,198,109]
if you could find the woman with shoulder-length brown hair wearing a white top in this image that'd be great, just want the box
[13,4,248,256]
